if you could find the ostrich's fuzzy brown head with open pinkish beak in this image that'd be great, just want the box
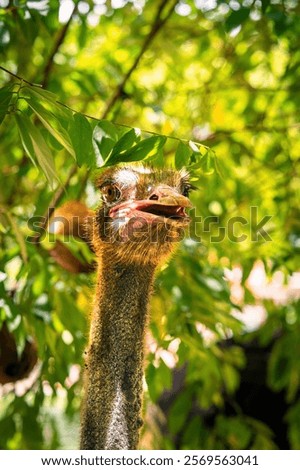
[93,165,192,264]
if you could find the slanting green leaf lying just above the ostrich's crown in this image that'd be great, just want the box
[105,136,167,166]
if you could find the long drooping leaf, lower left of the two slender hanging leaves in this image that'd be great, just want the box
[15,113,58,187]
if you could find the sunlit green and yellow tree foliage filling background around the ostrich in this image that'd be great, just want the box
[0,0,300,449]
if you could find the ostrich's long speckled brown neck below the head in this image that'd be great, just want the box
[81,255,154,449]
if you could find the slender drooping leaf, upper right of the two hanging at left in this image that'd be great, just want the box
[26,98,75,158]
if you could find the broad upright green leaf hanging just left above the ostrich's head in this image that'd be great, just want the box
[69,113,95,167]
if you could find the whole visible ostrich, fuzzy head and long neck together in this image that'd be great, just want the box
[81,165,191,449]
